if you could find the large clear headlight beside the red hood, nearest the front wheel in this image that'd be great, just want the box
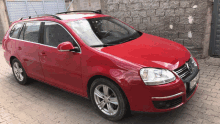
[140,68,176,85]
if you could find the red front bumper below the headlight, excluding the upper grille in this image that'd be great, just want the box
[129,72,199,112]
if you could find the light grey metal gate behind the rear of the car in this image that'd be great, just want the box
[6,0,66,22]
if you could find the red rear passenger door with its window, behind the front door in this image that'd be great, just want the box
[16,21,44,81]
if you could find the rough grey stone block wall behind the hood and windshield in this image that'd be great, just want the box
[101,0,211,58]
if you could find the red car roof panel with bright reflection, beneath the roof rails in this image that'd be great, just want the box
[13,12,108,23]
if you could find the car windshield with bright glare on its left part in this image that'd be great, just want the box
[67,17,141,47]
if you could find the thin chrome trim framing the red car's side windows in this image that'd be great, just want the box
[9,21,82,54]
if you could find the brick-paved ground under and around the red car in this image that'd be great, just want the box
[0,45,220,124]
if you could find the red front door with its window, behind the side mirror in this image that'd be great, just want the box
[40,21,82,93]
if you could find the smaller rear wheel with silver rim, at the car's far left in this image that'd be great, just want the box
[12,58,28,85]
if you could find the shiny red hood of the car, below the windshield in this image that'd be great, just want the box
[101,33,190,70]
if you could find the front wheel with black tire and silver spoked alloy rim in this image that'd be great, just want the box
[90,78,128,121]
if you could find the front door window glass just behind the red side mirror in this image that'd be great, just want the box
[44,22,77,47]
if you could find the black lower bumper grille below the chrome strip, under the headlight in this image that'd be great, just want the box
[153,96,182,109]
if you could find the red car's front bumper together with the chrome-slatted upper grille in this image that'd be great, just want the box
[125,58,199,112]
